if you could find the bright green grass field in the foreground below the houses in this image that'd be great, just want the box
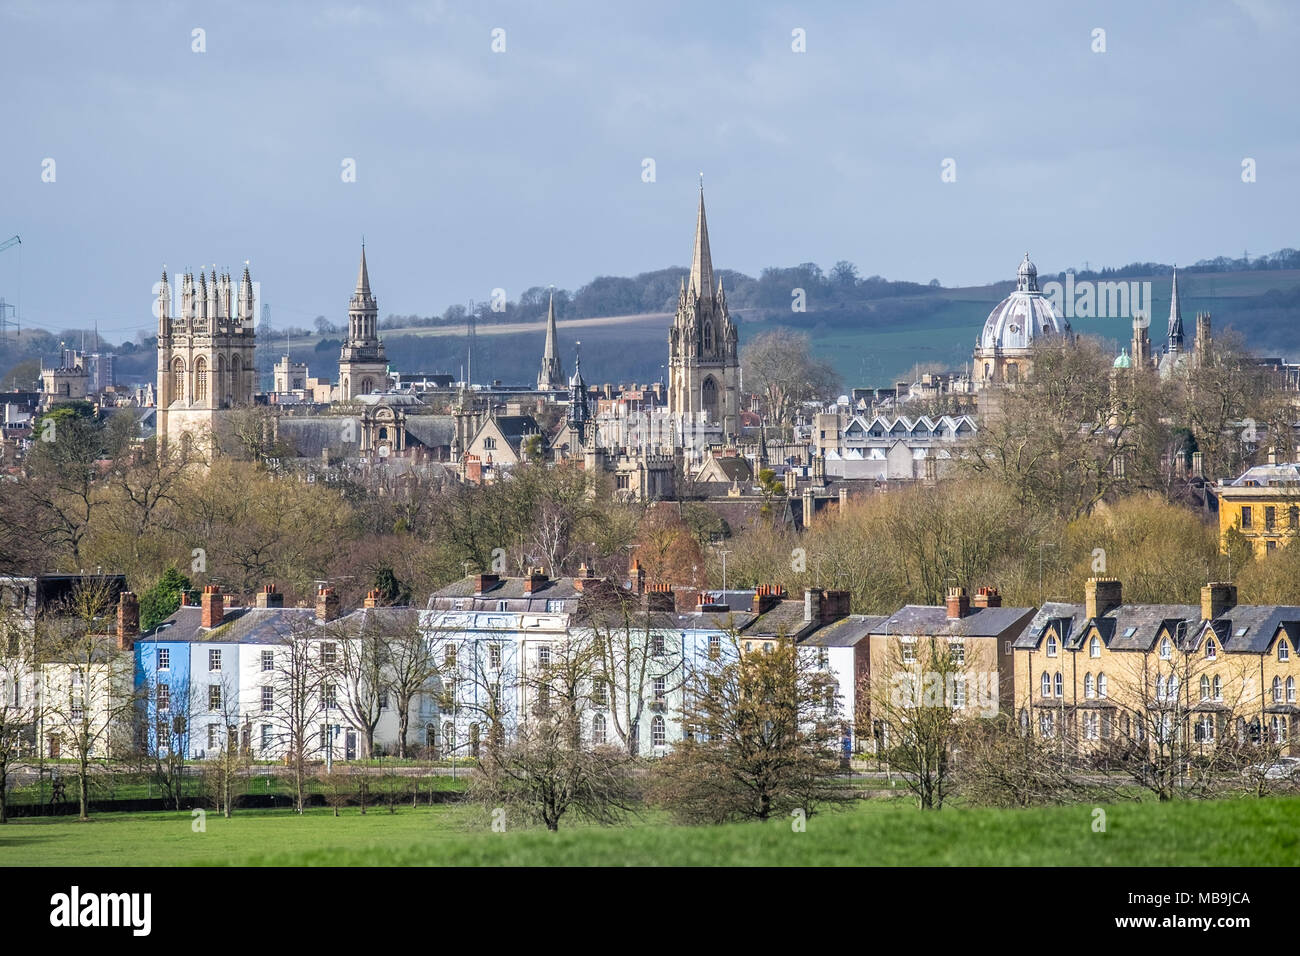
[0,797,1300,866]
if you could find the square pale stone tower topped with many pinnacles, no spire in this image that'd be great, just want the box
[157,265,257,453]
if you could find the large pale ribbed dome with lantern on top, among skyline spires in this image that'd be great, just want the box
[972,252,1070,388]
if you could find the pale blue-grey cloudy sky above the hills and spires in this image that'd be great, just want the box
[0,0,1300,341]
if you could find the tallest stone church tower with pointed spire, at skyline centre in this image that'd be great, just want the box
[668,186,740,436]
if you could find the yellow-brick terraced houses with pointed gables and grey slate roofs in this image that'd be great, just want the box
[1015,578,1300,753]
